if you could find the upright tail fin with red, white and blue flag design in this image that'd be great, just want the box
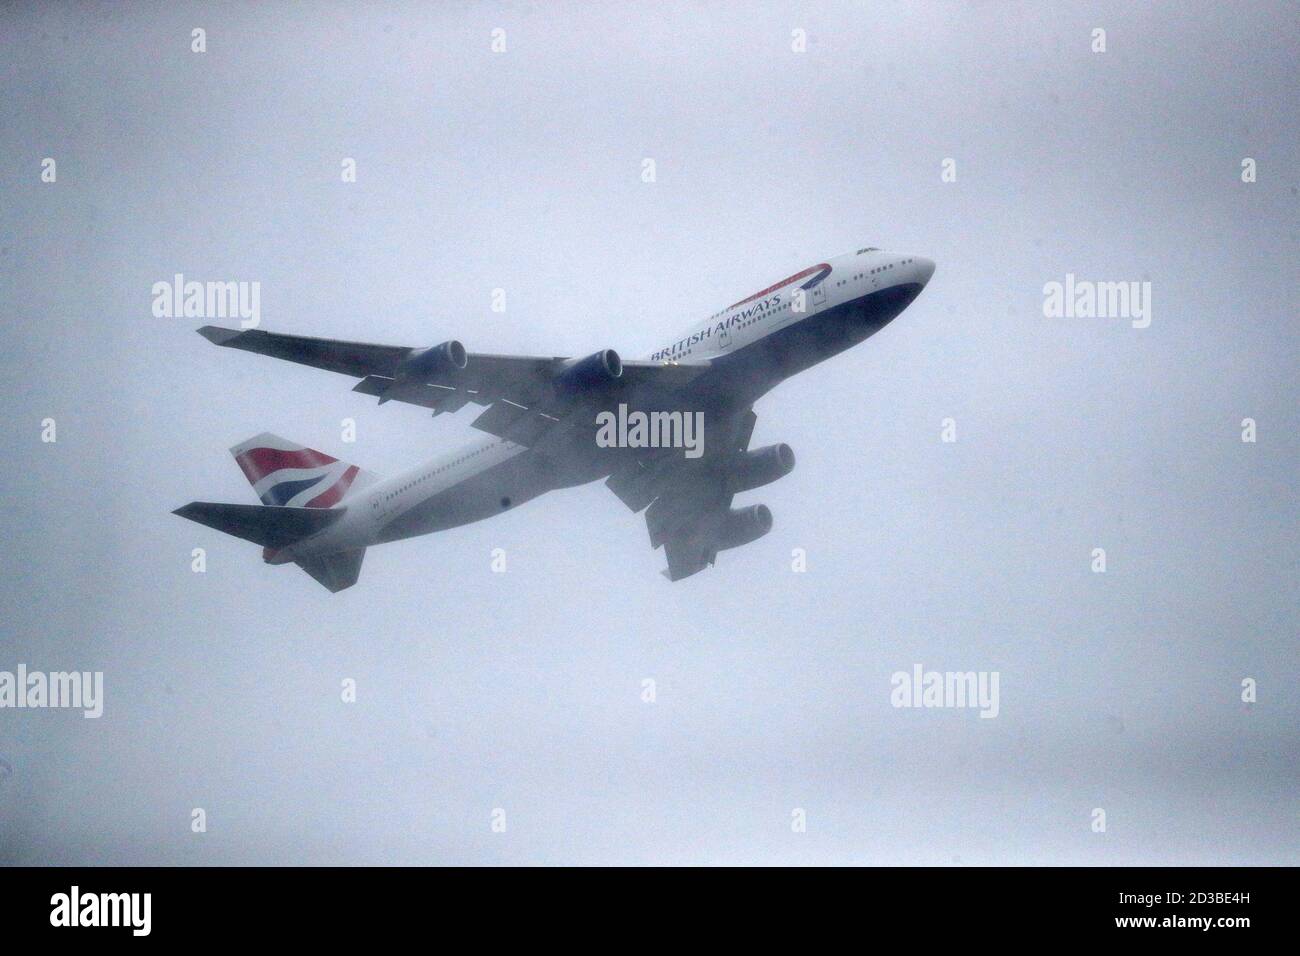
[230,432,376,509]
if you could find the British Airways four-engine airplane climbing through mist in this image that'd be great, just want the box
[173,247,935,592]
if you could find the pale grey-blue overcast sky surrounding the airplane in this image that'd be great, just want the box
[0,3,1300,865]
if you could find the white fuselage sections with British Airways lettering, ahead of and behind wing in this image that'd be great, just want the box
[272,248,935,563]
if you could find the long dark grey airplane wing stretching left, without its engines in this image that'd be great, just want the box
[199,325,709,418]
